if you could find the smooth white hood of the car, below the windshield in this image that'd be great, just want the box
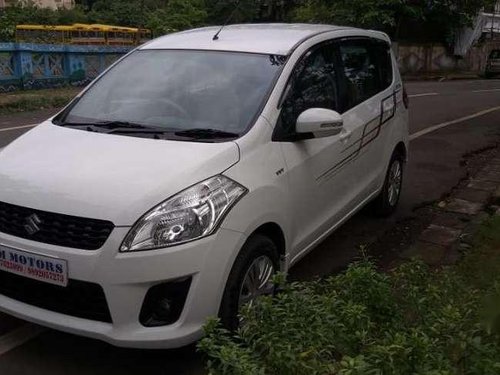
[0,122,239,226]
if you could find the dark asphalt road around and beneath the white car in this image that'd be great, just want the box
[0,80,500,375]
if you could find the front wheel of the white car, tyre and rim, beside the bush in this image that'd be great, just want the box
[219,234,279,330]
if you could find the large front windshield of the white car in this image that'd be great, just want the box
[57,50,284,134]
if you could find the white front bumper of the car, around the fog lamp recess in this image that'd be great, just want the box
[0,227,245,349]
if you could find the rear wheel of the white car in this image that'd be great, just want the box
[373,152,405,217]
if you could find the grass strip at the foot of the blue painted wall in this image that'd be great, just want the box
[0,87,81,115]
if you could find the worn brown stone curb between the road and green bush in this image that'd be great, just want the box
[399,149,500,267]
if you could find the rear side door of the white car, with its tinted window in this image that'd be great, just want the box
[338,38,396,207]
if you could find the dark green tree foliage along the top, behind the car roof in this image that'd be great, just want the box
[0,0,496,42]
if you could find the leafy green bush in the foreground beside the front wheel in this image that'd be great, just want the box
[199,261,500,375]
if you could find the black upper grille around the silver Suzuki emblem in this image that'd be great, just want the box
[0,202,114,250]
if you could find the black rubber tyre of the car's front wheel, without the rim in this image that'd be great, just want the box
[219,234,279,330]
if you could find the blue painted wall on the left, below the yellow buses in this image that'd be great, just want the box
[0,43,131,93]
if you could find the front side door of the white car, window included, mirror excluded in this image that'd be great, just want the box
[273,42,360,262]
